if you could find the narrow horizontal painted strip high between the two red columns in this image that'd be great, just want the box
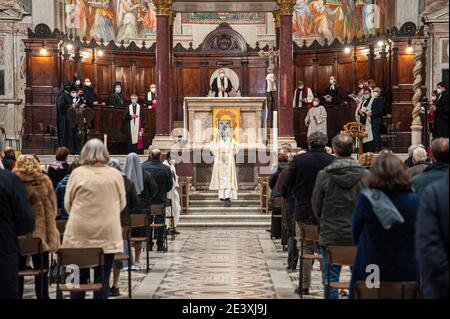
[181,12,266,24]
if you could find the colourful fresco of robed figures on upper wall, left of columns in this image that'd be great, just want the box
[65,0,156,43]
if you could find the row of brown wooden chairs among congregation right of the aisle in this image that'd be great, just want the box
[273,197,420,299]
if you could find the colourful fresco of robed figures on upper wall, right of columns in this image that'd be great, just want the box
[292,0,386,43]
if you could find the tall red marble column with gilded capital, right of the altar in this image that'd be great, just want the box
[277,0,296,147]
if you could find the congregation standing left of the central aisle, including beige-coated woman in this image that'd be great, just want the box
[0,139,181,299]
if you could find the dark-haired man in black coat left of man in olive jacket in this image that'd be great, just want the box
[285,132,334,295]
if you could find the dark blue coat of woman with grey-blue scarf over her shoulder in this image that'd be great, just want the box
[350,191,420,296]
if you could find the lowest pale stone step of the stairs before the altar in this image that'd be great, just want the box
[180,214,271,224]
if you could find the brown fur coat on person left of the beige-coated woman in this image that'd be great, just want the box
[16,171,60,252]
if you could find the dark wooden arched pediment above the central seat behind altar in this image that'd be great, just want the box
[200,23,247,53]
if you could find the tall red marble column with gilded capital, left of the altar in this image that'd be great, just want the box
[152,0,173,150]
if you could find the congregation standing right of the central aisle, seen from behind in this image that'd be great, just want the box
[268,132,449,299]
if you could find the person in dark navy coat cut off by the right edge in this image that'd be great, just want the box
[416,173,449,299]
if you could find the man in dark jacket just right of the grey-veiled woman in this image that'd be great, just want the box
[142,149,173,251]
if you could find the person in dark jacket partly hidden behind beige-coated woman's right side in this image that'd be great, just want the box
[109,159,142,297]
